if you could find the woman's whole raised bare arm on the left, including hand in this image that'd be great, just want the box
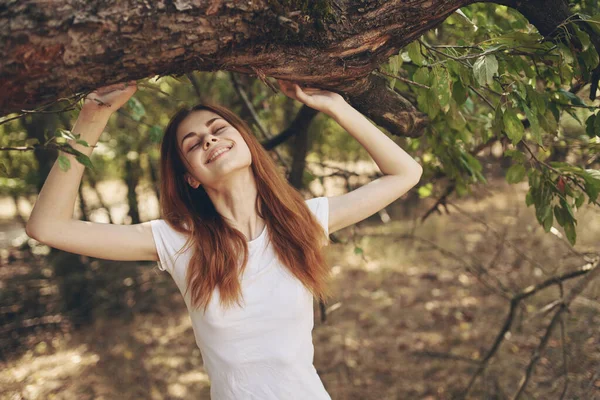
[26,82,158,261]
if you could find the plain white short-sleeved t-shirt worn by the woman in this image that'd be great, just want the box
[151,197,331,400]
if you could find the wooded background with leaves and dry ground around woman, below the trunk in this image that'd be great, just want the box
[0,0,600,399]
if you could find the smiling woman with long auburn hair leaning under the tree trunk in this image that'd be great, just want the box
[27,76,422,400]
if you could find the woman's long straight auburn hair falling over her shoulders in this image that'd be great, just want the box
[160,102,331,311]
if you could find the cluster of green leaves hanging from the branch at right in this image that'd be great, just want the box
[385,3,600,244]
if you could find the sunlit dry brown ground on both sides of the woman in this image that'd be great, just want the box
[0,179,600,400]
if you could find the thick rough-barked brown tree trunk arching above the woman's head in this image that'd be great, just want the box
[0,0,473,134]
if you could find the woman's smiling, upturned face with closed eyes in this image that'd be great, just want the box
[177,110,252,188]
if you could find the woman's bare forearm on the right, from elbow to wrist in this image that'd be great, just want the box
[327,103,423,179]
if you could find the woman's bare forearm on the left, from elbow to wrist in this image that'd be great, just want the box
[27,109,110,233]
